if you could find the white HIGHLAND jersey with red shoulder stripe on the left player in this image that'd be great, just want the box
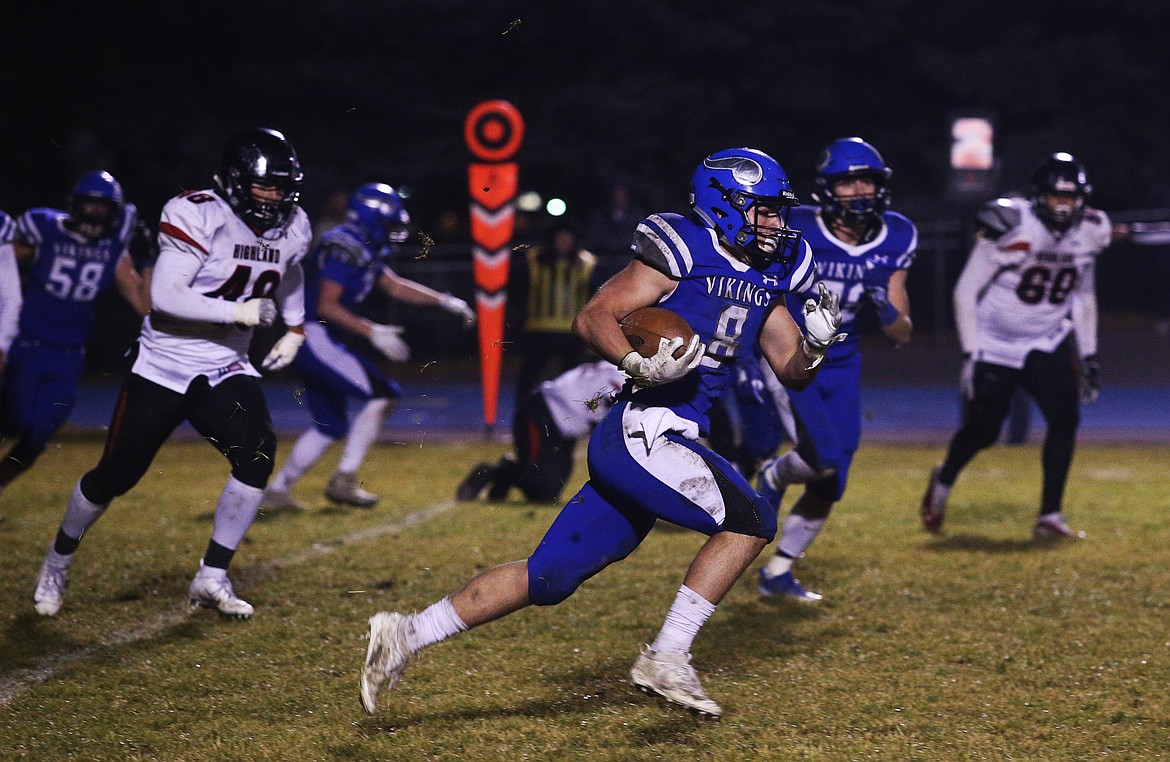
[133,191,312,393]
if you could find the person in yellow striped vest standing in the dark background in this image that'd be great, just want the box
[509,222,597,403]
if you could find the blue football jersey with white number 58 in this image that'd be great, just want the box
[16,204,138,346]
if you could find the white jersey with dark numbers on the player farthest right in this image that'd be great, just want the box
[956,198,1112,368]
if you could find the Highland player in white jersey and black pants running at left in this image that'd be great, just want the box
[34,129,312,619]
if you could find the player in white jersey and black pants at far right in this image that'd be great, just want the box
[920,152,1112,538]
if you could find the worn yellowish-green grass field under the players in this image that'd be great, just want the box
[0,439,1170,760]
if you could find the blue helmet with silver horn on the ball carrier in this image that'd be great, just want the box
[690,149,800,266]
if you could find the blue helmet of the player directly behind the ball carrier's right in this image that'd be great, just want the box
[812,138,893,224]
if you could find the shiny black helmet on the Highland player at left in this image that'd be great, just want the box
[215,128,304,231]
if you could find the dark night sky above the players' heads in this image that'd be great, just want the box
[0,0,1170,230]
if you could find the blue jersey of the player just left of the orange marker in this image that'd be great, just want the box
[304,224,386,321]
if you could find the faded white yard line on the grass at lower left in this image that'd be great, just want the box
[0,500,457,706]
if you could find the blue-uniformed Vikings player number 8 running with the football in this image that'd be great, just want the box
[360,149,841,718]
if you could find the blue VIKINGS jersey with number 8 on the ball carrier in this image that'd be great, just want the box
[624,214,815,435]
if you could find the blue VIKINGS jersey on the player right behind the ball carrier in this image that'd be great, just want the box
[787,201,918,361]
